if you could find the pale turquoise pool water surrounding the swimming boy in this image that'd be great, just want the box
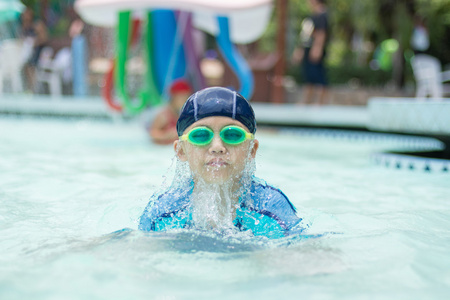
[0,117,450,300]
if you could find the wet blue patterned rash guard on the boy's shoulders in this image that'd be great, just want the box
[139,178,308,239]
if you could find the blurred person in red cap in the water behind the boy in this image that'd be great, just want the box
[149,79,192,145]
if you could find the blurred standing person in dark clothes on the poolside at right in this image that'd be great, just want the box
[292,0,329,104]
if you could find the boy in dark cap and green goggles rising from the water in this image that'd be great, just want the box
[139,87,305,238]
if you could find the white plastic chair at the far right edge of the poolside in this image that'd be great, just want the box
[411,54,450,98]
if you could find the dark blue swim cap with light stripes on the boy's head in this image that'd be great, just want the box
[177,87,256,136]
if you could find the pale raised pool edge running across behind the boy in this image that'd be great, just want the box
[0,94,450,137]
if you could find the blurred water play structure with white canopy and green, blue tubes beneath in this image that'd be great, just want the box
[75,0,272,114]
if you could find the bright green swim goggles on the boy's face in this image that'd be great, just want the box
[180,125,255,146]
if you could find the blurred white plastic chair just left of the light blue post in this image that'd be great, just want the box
[35,47,72,96]
